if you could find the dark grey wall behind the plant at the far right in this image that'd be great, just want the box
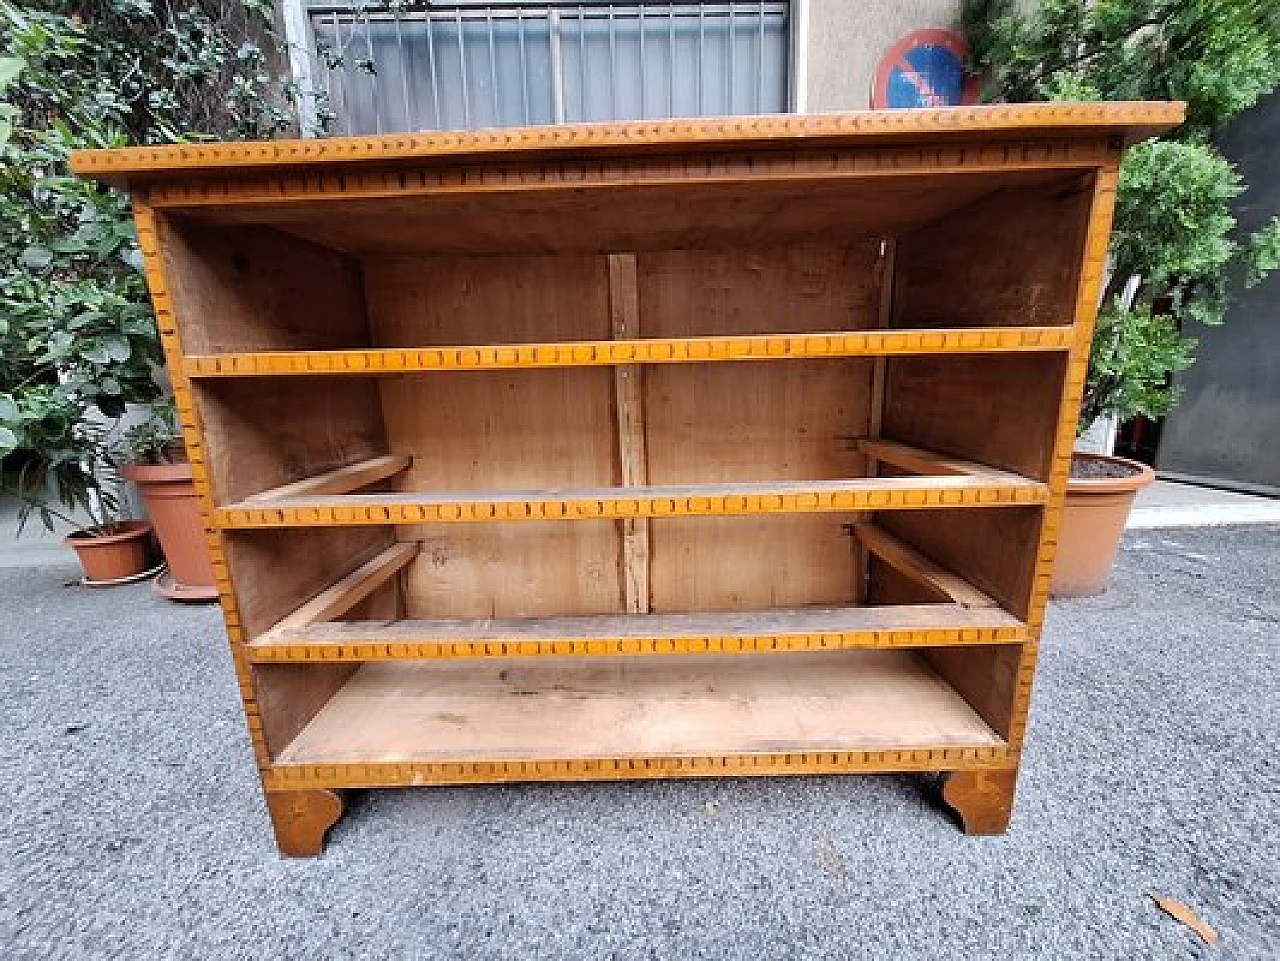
[1156,93,1280,489]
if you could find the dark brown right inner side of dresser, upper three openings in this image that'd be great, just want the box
[881,174,1093,617]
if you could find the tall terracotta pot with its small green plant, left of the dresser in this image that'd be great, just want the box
[120,402,218,600]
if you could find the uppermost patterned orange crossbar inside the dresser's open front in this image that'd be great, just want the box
[183,326,1074,379]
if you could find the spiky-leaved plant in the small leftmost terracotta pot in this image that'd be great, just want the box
[0,386,156,586]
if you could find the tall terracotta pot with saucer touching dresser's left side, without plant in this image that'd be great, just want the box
[120,463,218,600]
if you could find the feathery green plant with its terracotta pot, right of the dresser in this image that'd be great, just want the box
[964,0,1280,596]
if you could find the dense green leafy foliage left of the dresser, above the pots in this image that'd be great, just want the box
[0,0,304,534]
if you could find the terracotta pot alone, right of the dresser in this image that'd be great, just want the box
[1050,454,1156,598]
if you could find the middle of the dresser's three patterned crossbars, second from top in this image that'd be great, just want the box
[214,475,1048,530]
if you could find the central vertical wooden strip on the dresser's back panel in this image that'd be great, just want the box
[609,253,649,614]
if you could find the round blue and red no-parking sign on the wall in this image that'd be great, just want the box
[872,29,978,110]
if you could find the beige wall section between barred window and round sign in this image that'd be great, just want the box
[792,0,963,113]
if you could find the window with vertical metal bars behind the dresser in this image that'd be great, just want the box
[296,0,790,134]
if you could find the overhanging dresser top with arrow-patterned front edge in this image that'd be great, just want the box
[72,102,1187,187]
